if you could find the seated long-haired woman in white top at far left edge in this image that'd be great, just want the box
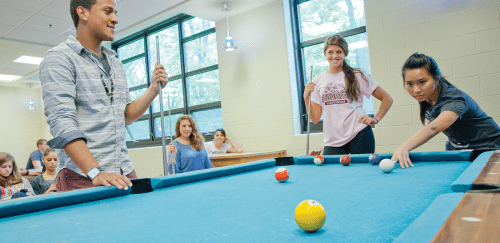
[0,152,35,201]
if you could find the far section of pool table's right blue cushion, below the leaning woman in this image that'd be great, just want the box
[451,151,494,192]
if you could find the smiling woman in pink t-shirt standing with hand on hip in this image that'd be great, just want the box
[304,35,392,155]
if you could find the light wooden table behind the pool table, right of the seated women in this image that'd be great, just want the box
[210,150,286,167]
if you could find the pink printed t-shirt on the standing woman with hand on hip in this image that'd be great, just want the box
[311,71,378,147]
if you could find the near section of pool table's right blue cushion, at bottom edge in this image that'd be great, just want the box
[394,193,464,243]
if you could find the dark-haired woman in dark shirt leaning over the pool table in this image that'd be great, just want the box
[392,53,500,169]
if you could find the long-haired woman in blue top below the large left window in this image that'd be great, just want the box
[168,115,213,174]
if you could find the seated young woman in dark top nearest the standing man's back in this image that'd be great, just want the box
[31,148,57,195]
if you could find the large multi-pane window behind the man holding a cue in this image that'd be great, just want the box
[112,14,222,148]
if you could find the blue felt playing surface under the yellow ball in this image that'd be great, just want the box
[0,162,470,242]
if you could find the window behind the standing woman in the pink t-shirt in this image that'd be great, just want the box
[290,0,373,132]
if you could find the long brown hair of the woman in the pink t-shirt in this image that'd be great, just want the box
[323,35,366,102]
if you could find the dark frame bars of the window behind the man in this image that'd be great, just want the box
[115,14,222,148]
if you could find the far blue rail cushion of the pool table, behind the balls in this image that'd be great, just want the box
[294,150,471,165]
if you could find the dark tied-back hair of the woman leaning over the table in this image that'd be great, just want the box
[401,52,453,125]
